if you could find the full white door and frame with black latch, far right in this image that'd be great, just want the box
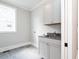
[61,0,78,59]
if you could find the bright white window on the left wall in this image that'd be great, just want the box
[0,4,16,32]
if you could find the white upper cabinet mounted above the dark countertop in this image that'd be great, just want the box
[44,0,61,24]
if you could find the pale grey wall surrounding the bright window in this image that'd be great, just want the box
[0,8,31,48]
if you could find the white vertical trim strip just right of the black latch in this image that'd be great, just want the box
[67,0,74,59]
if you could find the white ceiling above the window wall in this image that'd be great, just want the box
[0,0,43,10]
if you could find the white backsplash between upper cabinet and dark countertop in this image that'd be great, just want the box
[37,25,61,36]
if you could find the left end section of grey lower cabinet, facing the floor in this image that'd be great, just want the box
[39,42,49,59]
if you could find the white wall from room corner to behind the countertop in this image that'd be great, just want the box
[31,5,61,46]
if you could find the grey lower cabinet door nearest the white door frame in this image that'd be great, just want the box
[50,46,61,59]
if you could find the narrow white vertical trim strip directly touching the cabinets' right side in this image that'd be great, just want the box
[61,0,65,59]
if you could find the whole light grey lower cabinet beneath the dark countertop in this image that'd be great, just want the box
[39,38,61,59]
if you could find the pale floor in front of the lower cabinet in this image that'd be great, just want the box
[0,46,41,59]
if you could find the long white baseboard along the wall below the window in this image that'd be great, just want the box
[0,42,32,52]
